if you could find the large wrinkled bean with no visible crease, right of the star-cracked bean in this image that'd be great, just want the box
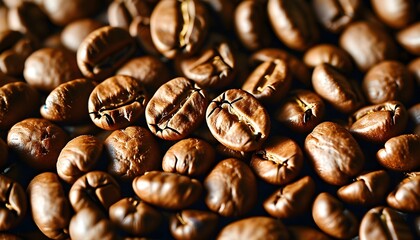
[305,122,364,186]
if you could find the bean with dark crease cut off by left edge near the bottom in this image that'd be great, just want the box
[0,175,27,232]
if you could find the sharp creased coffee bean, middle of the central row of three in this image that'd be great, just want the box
[146,77,208,140]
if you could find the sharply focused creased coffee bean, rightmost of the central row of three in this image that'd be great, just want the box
[206,89,271,151]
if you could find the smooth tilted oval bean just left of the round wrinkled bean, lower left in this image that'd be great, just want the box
[57,135,103,184]
